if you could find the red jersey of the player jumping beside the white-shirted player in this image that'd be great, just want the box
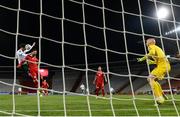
[25,55,39,70]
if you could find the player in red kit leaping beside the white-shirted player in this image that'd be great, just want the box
[17,50,39,88]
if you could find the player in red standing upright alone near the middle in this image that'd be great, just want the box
[93,66,106,96]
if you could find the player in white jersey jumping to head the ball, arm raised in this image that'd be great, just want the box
[16,42,36,75]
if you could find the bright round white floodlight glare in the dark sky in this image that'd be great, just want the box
[157,7,169,19]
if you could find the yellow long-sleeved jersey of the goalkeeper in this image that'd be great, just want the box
[148,45,169,65]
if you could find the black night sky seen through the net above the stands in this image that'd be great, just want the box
[0,0,180,66]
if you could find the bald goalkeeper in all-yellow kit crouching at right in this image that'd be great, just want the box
[138,38,171,104]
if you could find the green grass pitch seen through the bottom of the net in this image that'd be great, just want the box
[0,95,180,116]
